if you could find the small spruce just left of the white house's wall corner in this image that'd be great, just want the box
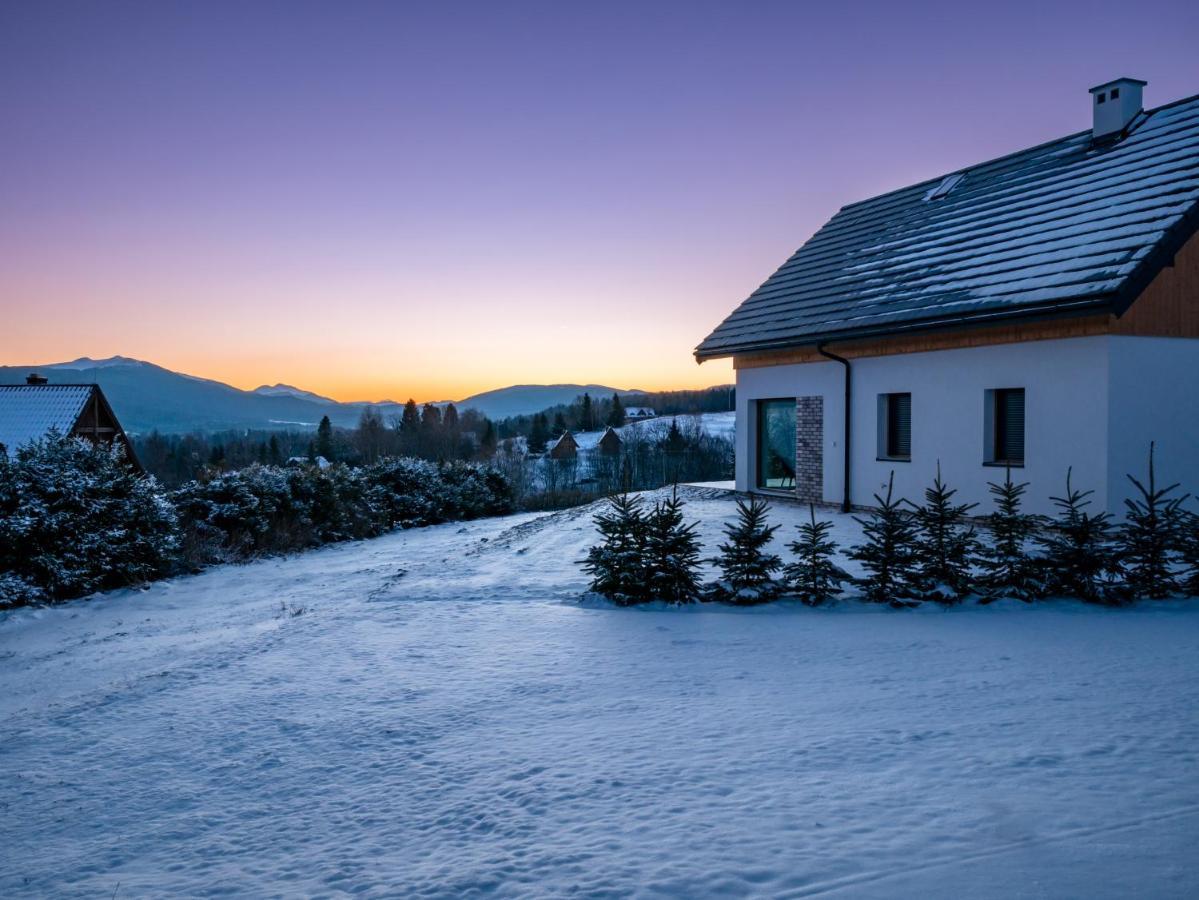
[1038,469,1117,603]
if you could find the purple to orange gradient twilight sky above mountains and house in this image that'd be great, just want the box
[0,0,1199,400]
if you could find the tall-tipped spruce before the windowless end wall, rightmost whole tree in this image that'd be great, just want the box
[1119,443,1186,600]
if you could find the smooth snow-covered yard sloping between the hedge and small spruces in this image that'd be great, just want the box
[0,489,1199,898]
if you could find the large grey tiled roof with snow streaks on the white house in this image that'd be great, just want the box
[695,90,1199,360]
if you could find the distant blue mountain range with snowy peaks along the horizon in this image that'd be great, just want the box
[0,356,640,433]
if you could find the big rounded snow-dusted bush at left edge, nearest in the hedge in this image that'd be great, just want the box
[0,431,179,606]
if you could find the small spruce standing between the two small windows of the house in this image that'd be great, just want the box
[915,461,981,605]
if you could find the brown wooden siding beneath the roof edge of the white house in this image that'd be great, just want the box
[733,235,1199,369]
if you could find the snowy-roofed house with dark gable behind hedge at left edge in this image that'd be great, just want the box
[0,374,140,469]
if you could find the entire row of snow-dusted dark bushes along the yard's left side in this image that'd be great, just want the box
[0,434,513,608]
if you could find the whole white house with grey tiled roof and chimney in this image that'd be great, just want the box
[695,78,1199,513]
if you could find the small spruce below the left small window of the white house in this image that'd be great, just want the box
[849,472,916,606]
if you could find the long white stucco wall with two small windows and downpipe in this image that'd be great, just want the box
[736,336,1117,513]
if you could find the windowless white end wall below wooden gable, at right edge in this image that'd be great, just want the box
[1108,337,1199,513]
